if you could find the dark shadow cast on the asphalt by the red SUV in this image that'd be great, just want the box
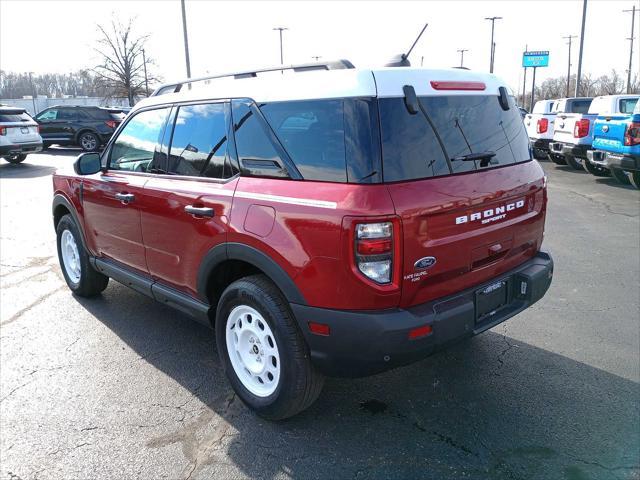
[78,281,640,480]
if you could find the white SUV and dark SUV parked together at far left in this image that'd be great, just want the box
[0,105,130,163]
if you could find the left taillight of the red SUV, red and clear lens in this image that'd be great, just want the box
[355,222,393,284]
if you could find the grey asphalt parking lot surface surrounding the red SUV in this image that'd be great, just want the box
[0,149,640,480]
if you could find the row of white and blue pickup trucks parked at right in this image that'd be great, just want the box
[524,95,640,188]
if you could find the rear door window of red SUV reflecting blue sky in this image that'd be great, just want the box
[167,103,230,178]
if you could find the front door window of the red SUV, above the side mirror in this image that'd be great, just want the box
[109,108,169,172]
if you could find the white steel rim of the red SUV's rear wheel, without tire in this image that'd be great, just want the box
[226,305,280,398]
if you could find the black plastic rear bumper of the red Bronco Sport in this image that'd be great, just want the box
[291,251,553,377]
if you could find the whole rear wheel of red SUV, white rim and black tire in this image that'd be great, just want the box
[215,275,324,420]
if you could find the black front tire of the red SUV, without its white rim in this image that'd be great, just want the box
[56,214,109,297]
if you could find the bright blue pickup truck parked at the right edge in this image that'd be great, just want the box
[587,99,640,189]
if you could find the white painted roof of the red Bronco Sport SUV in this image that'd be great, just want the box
[136,67,506,110]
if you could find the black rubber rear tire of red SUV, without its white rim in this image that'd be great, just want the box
[215,275,324,420]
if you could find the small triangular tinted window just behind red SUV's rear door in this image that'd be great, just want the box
[231,100,283,176]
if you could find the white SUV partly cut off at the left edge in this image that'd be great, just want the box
[0,106,42,163]
